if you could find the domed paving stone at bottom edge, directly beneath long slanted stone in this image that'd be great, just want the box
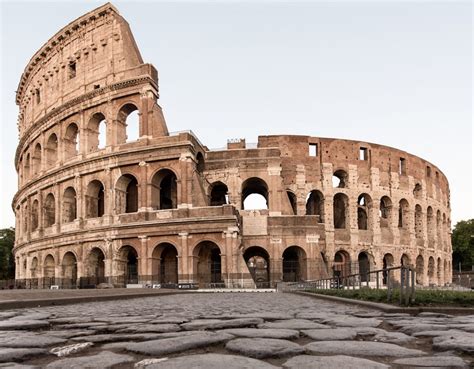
[137,354,278,369]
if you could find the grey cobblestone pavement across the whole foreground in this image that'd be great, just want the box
[0,293,474,369]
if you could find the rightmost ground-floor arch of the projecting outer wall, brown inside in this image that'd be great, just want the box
[193,241,222,288]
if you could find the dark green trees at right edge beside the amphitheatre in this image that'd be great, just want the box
[452,219,474,270]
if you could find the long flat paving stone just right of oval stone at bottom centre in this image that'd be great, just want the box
[305,341,426,357]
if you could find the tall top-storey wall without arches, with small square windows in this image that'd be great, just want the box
[16,3,151,136]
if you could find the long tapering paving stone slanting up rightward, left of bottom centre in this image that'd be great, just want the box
[126,332,234,355]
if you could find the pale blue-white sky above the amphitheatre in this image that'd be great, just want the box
[0,0,474,228]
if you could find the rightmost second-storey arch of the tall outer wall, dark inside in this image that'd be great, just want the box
[151,169,178,210]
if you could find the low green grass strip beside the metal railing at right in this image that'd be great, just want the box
[308,288,474,307]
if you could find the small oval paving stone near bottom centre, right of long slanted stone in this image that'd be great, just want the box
[225,338,305,359]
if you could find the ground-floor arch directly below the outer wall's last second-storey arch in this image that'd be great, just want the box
[152,243,178,285]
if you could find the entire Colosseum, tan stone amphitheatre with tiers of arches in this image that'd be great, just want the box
[13,3,452,288]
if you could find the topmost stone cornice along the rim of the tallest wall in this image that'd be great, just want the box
[16,3,119,105]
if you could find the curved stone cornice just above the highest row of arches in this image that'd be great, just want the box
[15,75,158,166]
